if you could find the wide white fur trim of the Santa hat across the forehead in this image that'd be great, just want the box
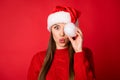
[47,11,71,31]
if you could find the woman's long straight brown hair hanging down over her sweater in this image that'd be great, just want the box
[38,32,75,80]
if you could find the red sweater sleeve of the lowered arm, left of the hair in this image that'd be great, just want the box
[27,53,43,80]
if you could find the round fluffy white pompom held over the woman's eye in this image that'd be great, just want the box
[64,23,76,37]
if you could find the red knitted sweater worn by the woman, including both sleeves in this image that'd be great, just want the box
[27,48,93,80]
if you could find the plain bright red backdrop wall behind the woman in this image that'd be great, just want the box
[0,0,120,80]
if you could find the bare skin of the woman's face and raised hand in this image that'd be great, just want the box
[51,23,83,53]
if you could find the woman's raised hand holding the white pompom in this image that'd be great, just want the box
[68,28,83,52]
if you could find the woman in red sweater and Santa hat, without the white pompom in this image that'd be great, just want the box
[28,6,95,80]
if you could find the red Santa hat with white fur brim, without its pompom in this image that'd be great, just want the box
[47,6,80,31]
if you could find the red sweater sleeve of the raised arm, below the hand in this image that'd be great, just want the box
[74,52,94,80]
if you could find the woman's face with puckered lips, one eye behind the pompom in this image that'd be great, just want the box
[51,23,69,49]
